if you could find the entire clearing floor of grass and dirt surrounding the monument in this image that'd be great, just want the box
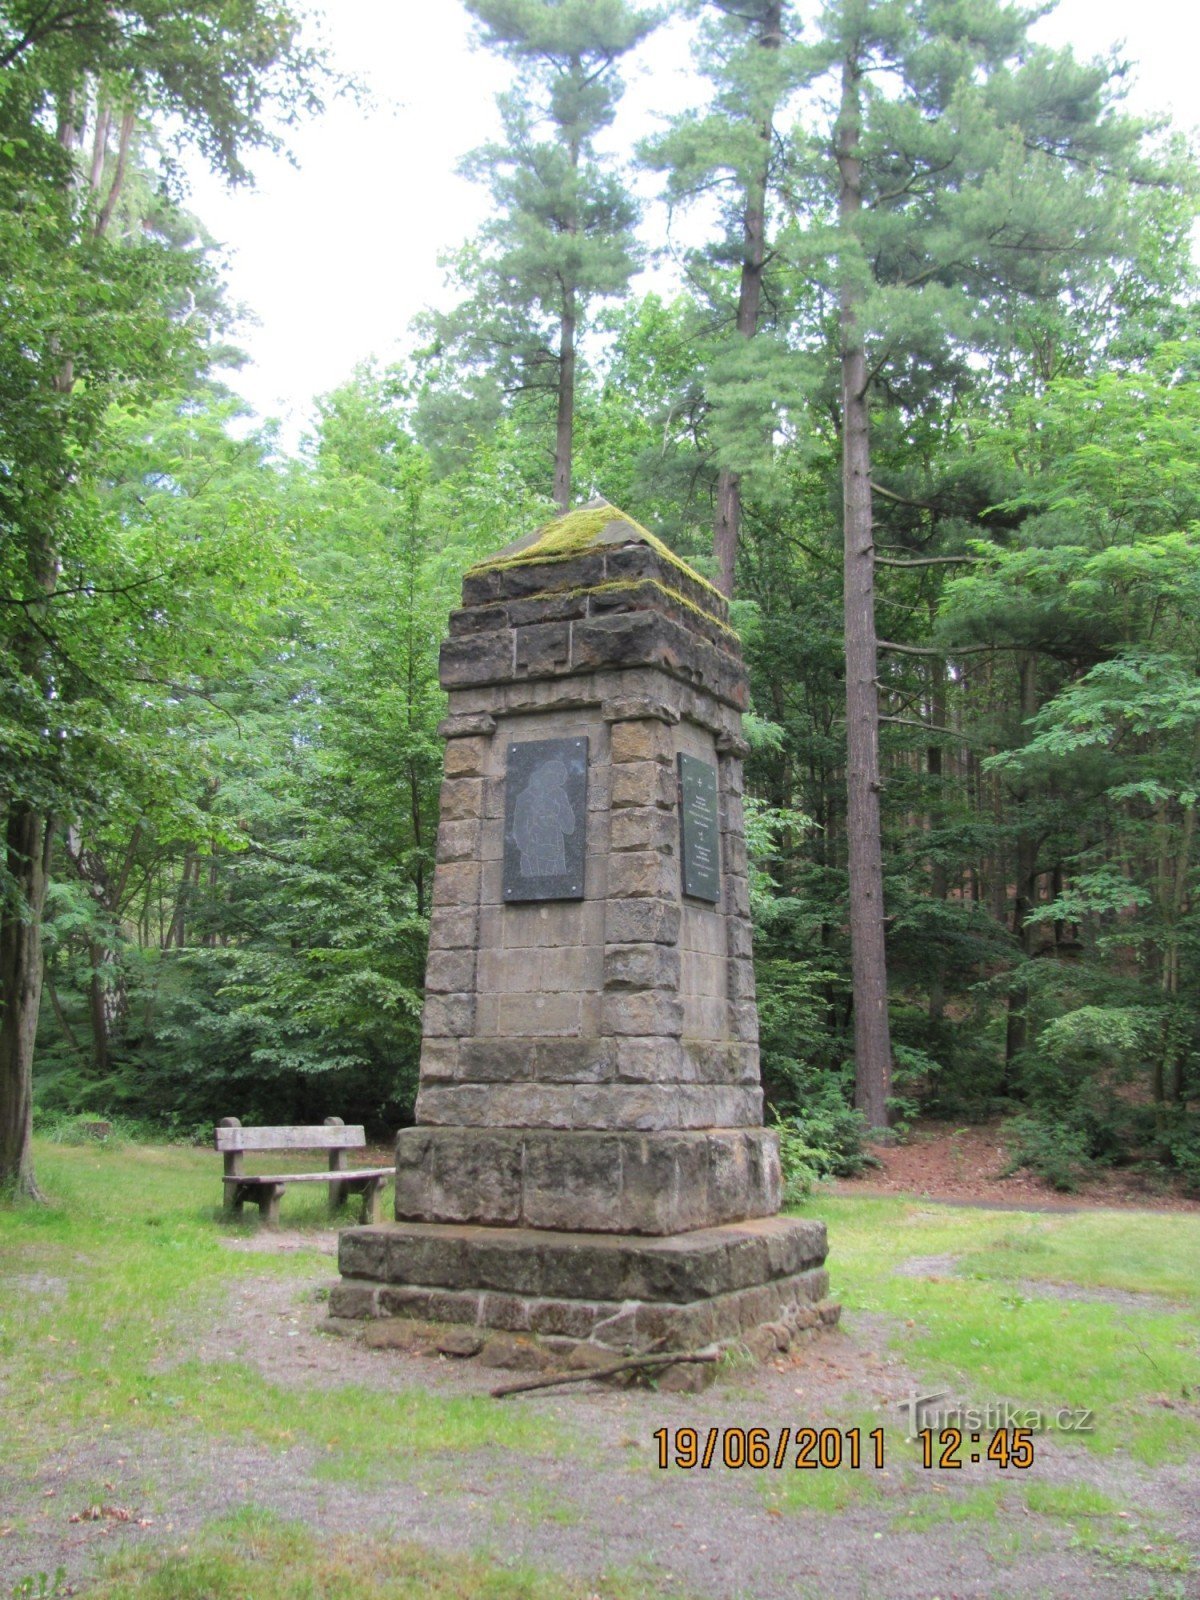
[0,1141,1200,1600]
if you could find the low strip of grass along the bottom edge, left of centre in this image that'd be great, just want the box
[77,1507,678,1600]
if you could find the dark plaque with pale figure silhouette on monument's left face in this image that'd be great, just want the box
[504,738,587,904]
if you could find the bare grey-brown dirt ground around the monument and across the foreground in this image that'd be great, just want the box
[0,1184,1200,1600]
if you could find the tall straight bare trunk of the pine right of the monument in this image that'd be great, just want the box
[837,50,891,1128]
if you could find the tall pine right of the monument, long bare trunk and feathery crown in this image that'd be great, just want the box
[794,0,1158,1126]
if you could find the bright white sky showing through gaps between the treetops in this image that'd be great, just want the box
[190,0,1200,445]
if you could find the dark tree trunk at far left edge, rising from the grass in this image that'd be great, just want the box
[0,800,54,1200]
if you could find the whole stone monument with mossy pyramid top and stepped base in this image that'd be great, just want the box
[330,501,837,1352]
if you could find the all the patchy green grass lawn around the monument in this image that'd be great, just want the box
[0,1142,1200,1600]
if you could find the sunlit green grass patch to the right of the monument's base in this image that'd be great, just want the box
[803,1195,1200,1464]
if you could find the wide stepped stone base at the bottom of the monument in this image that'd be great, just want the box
[330,1216,838,1352]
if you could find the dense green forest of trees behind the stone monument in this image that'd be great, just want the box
[0,0,1200,1194]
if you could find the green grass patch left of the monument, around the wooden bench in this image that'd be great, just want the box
[0,1144,568,1478]
